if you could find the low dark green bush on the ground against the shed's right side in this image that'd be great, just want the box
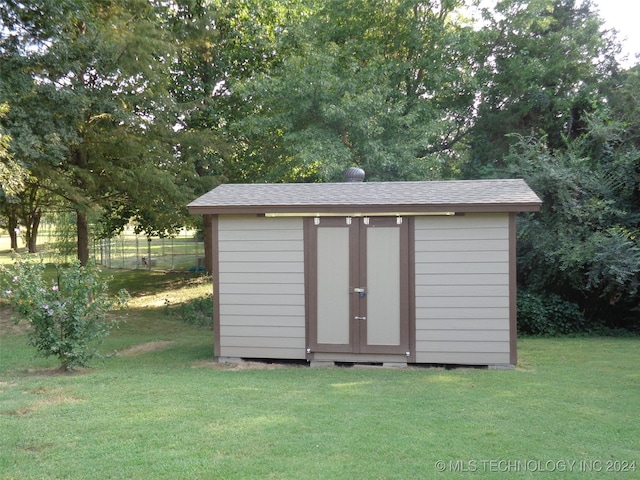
[518,291,587,336]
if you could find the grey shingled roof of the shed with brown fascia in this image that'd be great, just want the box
[188,179,542,214]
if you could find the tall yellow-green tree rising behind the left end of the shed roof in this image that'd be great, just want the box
[167,0,310,185]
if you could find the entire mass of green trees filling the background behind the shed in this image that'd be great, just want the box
[0,0,640,328]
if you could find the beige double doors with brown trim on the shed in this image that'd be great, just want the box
[308,217,409,354]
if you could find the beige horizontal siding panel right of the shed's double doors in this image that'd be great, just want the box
[415,214,509,365]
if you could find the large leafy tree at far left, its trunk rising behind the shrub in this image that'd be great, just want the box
[0,0,191,264]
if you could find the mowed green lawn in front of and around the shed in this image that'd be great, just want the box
[0,272,640,479]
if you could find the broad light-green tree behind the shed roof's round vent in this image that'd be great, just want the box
[225,0,475,181]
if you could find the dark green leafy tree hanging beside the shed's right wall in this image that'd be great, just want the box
[506,122,640,327]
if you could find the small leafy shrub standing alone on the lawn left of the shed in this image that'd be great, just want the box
[0,258,128,370]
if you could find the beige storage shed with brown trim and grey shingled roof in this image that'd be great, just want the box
[189,179,541,366]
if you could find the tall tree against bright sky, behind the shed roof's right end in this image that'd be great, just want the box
[465,0,619,176]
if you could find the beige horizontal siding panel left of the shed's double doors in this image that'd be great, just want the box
[217,216,306,359]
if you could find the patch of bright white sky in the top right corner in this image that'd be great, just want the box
[592,0,640,66]
